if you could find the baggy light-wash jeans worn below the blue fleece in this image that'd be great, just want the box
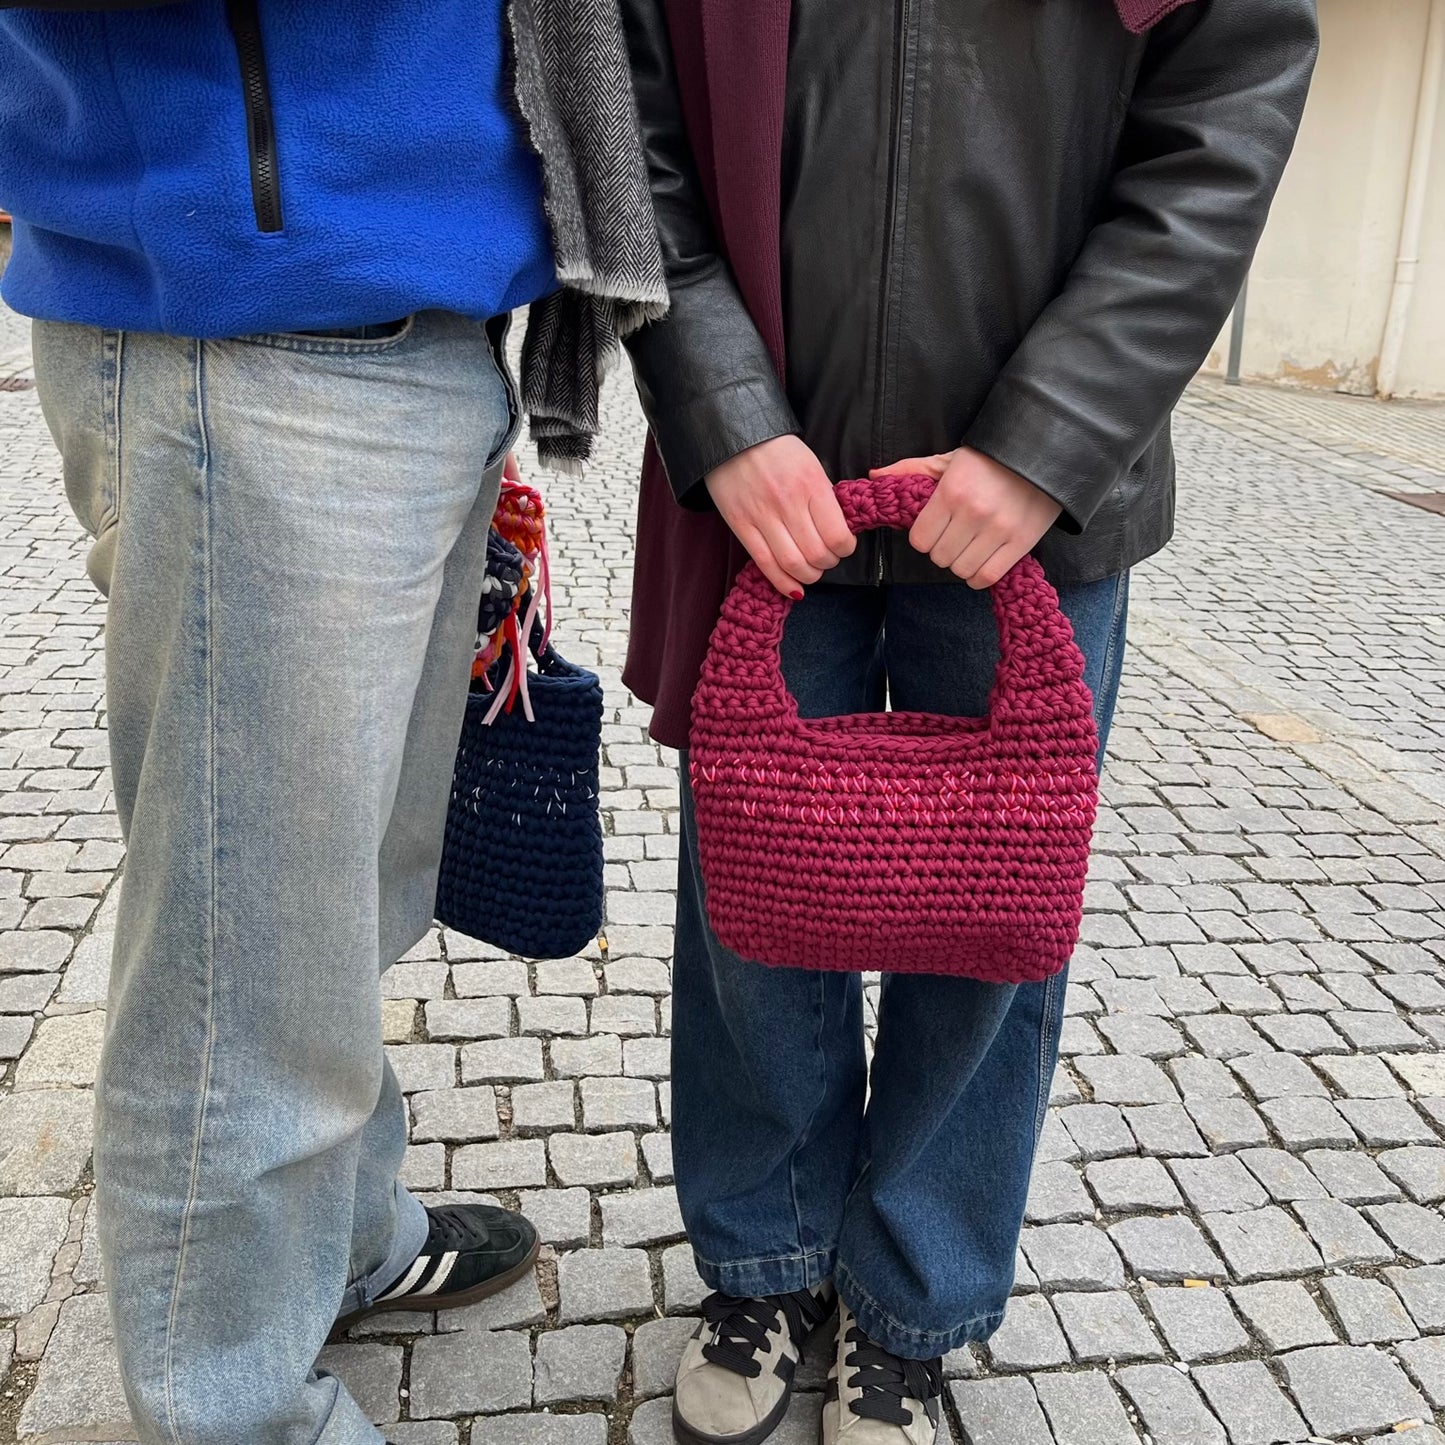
[35,312,516,1445]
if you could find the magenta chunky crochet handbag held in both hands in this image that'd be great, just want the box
[689,477,1098,983]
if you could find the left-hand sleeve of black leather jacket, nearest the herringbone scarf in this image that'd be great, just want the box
[621,0,798,510]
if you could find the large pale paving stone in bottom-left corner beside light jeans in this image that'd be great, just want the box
[20,1295,134,1441]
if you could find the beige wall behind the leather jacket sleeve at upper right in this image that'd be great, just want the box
[1207,0,1445,396]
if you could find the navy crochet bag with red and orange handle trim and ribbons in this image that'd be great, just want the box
[436,483,603,958]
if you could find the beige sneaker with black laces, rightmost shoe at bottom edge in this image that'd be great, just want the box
[819,1305,944,1445]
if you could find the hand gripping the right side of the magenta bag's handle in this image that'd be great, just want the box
[868,447,1064,588]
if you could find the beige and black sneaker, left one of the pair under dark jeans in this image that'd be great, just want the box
[672,1283,837,1445]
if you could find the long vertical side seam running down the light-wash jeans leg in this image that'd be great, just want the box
[163,341,218,1445]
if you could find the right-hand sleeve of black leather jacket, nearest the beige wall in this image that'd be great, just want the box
[964,0,1318,532]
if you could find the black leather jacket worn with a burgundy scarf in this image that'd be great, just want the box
[621,0,1316,582]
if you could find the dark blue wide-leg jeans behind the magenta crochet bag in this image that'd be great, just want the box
[672,574,1129,1360]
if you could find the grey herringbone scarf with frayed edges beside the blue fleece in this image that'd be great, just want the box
[509,0,668,471]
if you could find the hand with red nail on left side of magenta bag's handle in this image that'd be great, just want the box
[707,436,858,601]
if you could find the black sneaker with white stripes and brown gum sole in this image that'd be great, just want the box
[331,1204,540,1340]
